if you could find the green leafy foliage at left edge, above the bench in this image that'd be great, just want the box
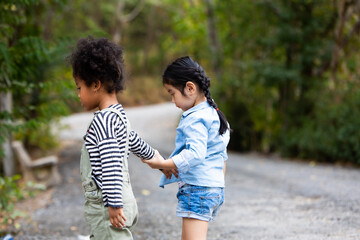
[0,1,75,159]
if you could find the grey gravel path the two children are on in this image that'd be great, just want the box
[16,103,360,240]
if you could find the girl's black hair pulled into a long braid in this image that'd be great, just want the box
[163,56,229,135]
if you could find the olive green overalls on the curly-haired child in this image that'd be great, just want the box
[80,144,138,240]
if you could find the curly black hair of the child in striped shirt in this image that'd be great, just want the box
[68,36,125,93]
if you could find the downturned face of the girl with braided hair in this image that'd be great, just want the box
[164,83,196,111]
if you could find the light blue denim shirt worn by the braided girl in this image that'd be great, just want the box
[159,101,230,187]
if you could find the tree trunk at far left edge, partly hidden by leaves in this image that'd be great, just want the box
[0,91,15,177]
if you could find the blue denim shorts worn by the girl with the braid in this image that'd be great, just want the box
[176,184,224,222]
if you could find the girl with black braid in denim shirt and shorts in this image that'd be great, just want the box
[143,56,230,240]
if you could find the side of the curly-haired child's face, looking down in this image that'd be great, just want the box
[75,77,99,111]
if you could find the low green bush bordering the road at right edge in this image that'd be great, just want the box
[281,88,360,164]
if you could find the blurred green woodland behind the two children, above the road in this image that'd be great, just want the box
[0,0,360,234]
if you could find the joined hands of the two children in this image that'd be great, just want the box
[141,150,179,179]
